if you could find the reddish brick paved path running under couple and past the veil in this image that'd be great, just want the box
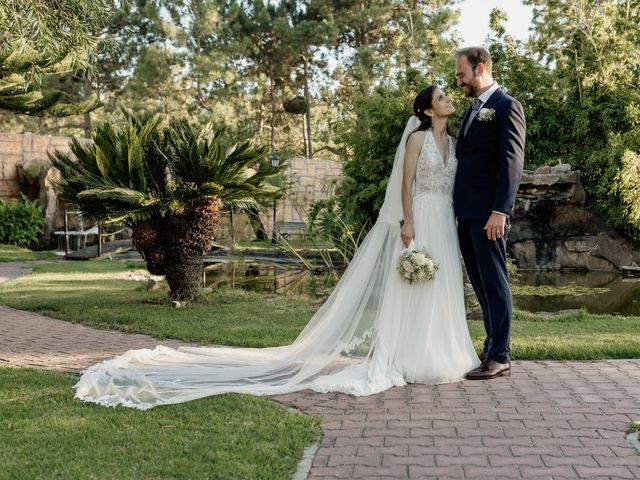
[0,264,640,480]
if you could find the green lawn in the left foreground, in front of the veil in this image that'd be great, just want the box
[0,367,320,480]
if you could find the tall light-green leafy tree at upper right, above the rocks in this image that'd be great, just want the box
[527,0,640,238]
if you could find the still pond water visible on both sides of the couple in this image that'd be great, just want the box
[205,258,640,316]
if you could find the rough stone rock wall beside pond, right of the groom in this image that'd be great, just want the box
[507,164,640,271]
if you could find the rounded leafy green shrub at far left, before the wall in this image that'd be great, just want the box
[0,195,44,247]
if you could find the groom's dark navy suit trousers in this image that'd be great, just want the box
[458,219,512,363]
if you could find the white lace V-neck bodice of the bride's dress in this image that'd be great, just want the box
[413,130,458,198]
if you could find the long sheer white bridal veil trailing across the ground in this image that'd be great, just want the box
[75,117,420,410]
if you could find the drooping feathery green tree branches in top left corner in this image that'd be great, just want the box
[0,0,109,116]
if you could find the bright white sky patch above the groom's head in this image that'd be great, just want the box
[456,0,533,47]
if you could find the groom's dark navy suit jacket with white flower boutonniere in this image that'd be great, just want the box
[453,89,525,220]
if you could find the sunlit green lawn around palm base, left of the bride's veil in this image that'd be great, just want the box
[0,261,316,347]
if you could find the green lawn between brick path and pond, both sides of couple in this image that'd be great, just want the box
[0,261,640,360]
